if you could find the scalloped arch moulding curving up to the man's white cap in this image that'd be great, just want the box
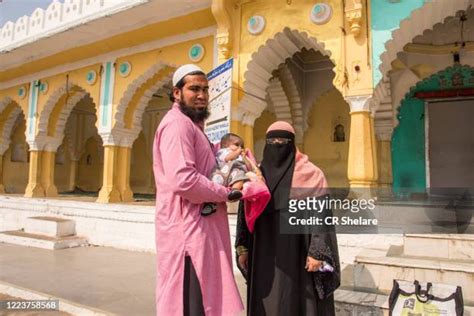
[115,62,175,129]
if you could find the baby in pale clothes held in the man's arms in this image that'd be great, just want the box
[201,133,252,216]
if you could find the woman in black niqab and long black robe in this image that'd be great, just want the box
[236,122,340,316]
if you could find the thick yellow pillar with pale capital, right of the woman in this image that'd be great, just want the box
[346,95,378,195]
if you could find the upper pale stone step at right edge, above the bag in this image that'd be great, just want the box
[403,234,474,264]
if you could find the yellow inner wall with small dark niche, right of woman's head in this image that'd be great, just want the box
[303,88,350,187]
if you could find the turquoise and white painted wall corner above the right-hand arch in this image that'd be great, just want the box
[370,0,428,87]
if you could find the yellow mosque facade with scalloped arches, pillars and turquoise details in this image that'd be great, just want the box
[0,0,474,203]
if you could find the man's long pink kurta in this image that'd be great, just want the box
[153,104,243,316]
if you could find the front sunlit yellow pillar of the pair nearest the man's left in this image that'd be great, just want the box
[97,145,121,203]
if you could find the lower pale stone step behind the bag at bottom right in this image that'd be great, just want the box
[353,251,474,305]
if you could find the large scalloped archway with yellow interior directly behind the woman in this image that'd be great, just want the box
[241,28,350,187]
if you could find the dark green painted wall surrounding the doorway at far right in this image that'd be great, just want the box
[392,66,474,195]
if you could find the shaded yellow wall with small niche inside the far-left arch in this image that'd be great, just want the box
[3,114,29,193]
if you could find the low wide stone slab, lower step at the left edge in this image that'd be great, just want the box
[0,230,89,250]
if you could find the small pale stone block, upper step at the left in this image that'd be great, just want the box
[24,216,76,237]
